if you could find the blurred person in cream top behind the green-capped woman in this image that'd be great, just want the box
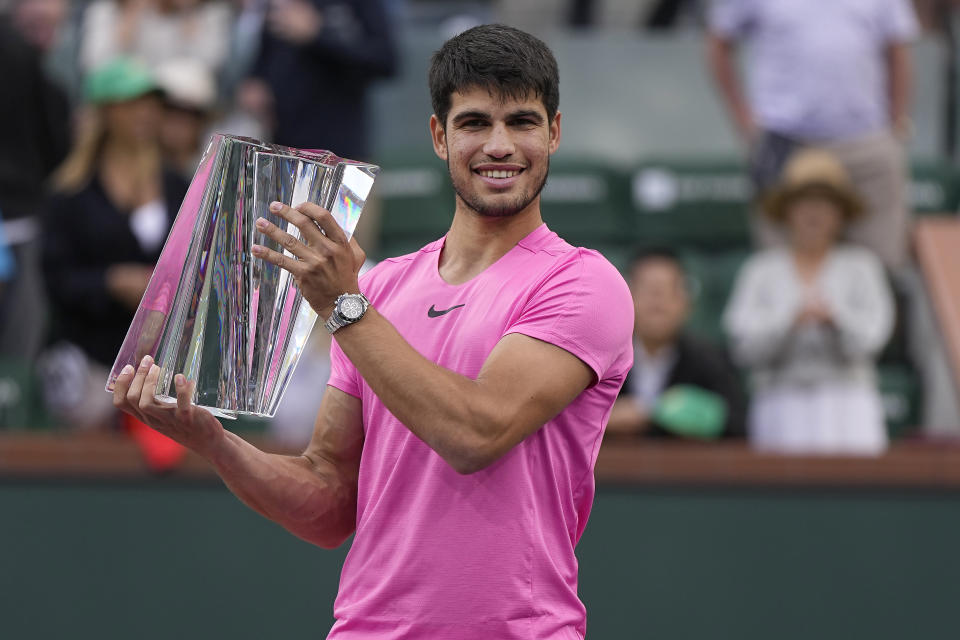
[80,0,233,73]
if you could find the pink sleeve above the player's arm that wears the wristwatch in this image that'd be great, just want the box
[504,249,633,381]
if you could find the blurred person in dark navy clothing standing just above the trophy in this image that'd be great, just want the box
[238,0,397,159]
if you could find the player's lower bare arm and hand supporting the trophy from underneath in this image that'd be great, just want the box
[114,361,363,548]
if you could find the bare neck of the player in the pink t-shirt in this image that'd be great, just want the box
[440,198,543,284]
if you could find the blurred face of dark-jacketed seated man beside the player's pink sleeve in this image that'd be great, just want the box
[630,258,690,343]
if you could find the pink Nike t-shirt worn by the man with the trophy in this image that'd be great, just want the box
[329,225,633,640]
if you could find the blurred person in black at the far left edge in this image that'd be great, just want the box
[0,0,70,360]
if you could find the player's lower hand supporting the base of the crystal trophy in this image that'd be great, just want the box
[113,356,224,458]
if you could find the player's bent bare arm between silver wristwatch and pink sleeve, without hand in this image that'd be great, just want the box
[337,308,594,473]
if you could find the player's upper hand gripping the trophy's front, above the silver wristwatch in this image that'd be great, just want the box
[252,202,366,318]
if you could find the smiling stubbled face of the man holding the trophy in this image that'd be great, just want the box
[430,88,560,217]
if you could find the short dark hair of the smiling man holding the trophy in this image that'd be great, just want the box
[430,24,560,127]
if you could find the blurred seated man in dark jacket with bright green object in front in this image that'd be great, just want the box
[607,249,746,438]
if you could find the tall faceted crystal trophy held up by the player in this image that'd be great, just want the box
[106,134,379,418]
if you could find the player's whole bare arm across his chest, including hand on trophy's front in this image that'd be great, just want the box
[254,204,632,473]
